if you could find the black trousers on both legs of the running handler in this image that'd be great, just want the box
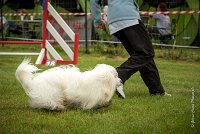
[114,20,164,94]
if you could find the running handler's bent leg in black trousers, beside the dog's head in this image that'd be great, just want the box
[114,20,154,83]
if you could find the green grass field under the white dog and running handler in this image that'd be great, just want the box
[0,45,200,134]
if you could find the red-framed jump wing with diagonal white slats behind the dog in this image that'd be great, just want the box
[35,0,79,65]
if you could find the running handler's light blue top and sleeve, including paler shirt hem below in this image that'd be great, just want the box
[90,0,140,34]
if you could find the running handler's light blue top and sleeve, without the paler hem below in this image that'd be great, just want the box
[90,0,140,24]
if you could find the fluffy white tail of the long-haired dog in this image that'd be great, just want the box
[15,59,39,86]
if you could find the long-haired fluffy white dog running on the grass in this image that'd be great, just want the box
[15,59,123,110]
